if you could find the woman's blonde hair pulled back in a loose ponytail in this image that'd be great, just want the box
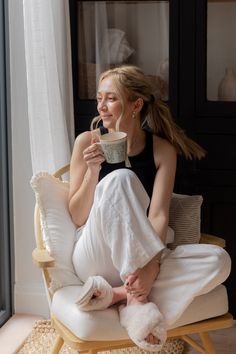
[91,65,206,159]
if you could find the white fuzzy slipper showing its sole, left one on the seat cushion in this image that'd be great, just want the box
[75,275,113,311]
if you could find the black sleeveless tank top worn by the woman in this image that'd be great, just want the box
[99,126,156,199]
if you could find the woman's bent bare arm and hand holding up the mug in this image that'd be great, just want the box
[69,132,104,226]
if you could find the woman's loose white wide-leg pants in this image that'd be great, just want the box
[73,169,231,325]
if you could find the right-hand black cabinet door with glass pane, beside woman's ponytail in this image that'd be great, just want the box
[176,0,236,314]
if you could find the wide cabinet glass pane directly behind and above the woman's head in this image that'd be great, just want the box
[77,1,169,100]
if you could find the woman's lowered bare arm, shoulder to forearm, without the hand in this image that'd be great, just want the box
[148,136,177,243]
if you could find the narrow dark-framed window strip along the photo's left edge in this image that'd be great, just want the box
[0,1,11,326]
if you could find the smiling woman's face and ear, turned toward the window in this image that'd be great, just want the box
[97,77,132,130]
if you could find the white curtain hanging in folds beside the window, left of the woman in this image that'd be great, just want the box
[23,0,74,173]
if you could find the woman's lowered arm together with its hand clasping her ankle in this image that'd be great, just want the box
[126,136,177,301]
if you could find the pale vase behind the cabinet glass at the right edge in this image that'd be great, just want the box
[218,67,236,101]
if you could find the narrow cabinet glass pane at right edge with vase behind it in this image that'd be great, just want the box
[207,0,236,101]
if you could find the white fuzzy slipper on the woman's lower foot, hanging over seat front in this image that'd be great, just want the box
[119,302,167,352]
